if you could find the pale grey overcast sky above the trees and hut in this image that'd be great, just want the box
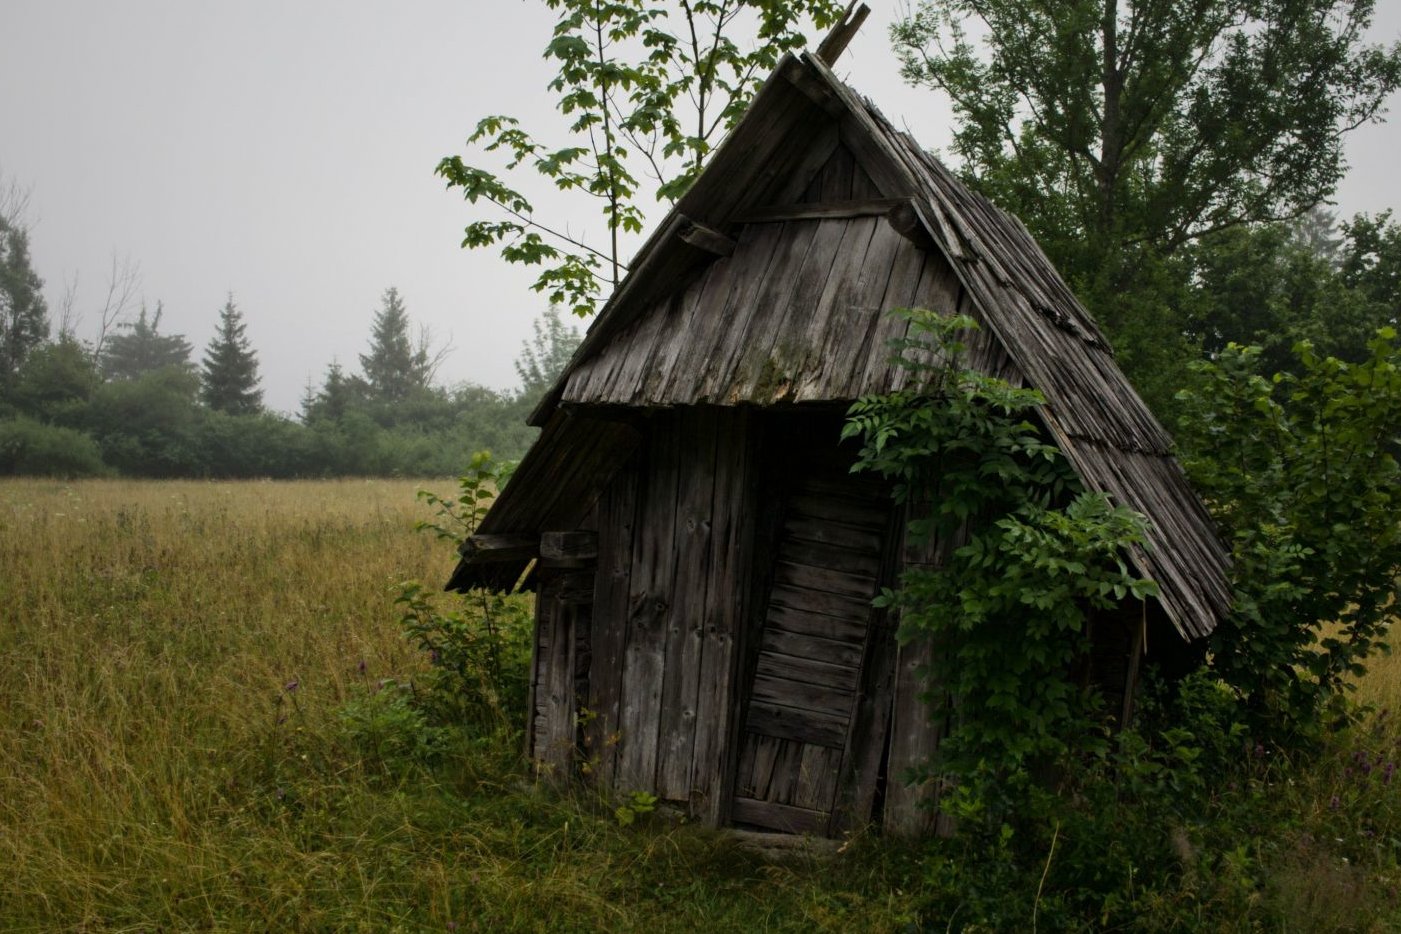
[0,0,1401,412]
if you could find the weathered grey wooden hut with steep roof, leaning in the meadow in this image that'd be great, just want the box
[448,14,1229,835]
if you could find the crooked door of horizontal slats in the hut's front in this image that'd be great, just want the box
[731,448,892,835]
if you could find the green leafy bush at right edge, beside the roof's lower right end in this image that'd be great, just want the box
[1178,328,1401,738]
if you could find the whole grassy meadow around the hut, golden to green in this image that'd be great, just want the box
[0,480,1401,933]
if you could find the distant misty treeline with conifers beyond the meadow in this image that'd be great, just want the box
[0,266,579,478]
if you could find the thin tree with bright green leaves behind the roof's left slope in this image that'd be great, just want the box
[437,0,842,315]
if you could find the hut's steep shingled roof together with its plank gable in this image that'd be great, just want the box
[450,45,1230,639]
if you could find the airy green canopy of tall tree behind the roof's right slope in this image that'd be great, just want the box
[892,0,1401,288]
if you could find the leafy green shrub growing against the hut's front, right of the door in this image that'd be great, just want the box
[843,311,1156,826]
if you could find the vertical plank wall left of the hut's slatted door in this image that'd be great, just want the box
[584,407,754,821]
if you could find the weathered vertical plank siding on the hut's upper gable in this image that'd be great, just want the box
[562,146,1020,405]
